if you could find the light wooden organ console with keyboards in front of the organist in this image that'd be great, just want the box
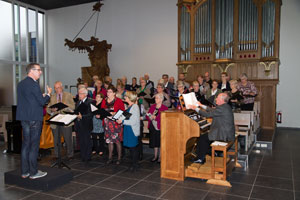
[161,110,211,181]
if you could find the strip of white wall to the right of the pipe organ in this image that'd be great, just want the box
[277,0,300,128]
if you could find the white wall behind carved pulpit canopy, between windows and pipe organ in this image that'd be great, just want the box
[48,0,177,88]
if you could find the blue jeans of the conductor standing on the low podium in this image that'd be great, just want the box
[21,121,43,176]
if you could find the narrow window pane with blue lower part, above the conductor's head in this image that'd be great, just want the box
[28,9,37,62]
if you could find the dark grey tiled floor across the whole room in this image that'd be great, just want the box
[0,129,300,200]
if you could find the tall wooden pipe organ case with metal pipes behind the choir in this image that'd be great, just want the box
[177,0,282,129]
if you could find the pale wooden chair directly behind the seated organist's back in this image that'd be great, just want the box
[234,113,251,151]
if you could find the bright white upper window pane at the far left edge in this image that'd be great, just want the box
[0,0,13,60]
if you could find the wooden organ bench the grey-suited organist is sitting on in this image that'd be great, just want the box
[207,135,241,187]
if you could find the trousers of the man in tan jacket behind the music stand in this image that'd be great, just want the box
[52,126,74,158]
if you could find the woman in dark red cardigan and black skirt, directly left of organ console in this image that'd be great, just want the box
[147,93,168,162]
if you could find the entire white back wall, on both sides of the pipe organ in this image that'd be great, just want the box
[48,0,300,128]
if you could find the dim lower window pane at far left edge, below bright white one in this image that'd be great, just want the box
[0,63,13,106]
